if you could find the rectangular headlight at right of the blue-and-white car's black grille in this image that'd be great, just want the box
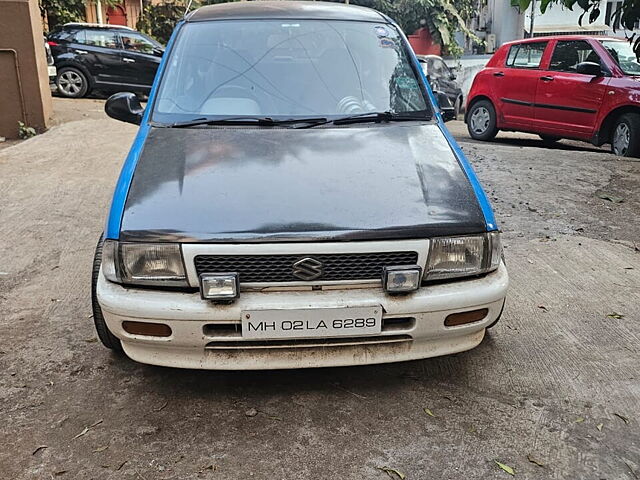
[424,232,502,281]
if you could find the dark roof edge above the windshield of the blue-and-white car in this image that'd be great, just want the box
[186,0,390,22]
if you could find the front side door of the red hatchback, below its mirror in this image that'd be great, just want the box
[534,40,609,138]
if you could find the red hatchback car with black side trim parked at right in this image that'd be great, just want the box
[465,36,640,157]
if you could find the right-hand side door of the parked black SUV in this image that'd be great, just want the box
[119,31,161,89]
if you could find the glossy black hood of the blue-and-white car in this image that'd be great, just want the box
[120,122,486,242]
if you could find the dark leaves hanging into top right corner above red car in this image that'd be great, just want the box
[511,0,640,57]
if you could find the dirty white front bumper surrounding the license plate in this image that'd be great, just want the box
[97,263,509,370]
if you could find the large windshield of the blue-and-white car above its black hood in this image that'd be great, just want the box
[152,20,430,123]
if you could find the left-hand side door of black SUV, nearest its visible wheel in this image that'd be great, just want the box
[68,29,124,84]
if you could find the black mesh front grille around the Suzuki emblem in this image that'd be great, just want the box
[195,252,418,283]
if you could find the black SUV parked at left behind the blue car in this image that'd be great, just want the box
[48,23,164,98]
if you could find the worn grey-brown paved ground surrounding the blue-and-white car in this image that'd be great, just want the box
[0,99,640,480]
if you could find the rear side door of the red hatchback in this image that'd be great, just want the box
[493,41,548,130]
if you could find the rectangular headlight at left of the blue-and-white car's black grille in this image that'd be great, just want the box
[102,240,188,287]
